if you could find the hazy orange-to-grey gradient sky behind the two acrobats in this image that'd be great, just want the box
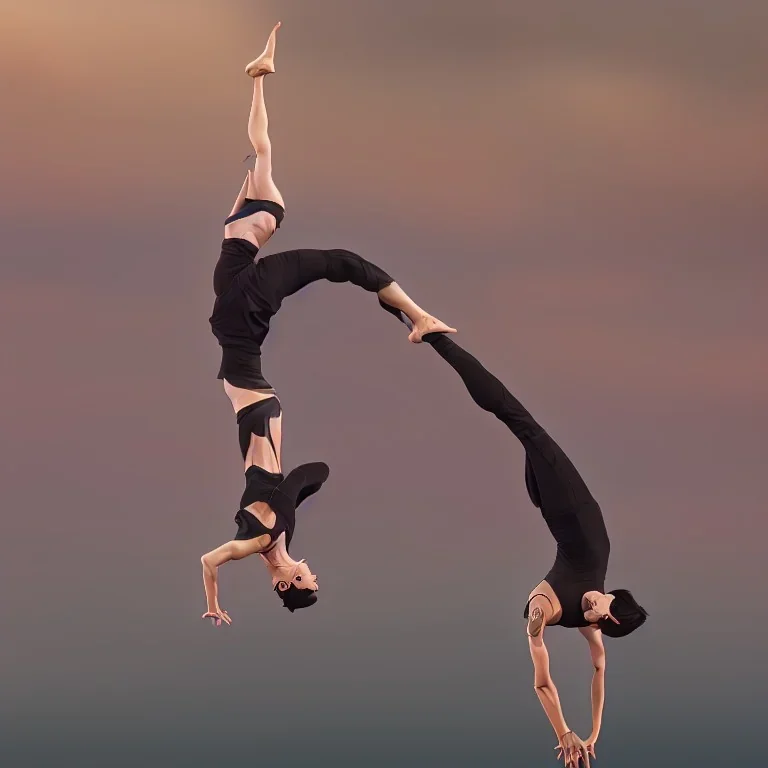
[0,0,768,768]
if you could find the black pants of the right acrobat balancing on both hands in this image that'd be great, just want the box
[424,334,594,515]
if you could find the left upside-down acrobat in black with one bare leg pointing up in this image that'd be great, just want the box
[202,24,454,626]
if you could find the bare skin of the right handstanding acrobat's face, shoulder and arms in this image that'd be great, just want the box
[527,581,619,768]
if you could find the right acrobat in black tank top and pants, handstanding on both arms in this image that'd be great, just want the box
[390,318,647,766]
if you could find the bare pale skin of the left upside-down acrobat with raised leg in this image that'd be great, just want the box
[201,23,456,627]
